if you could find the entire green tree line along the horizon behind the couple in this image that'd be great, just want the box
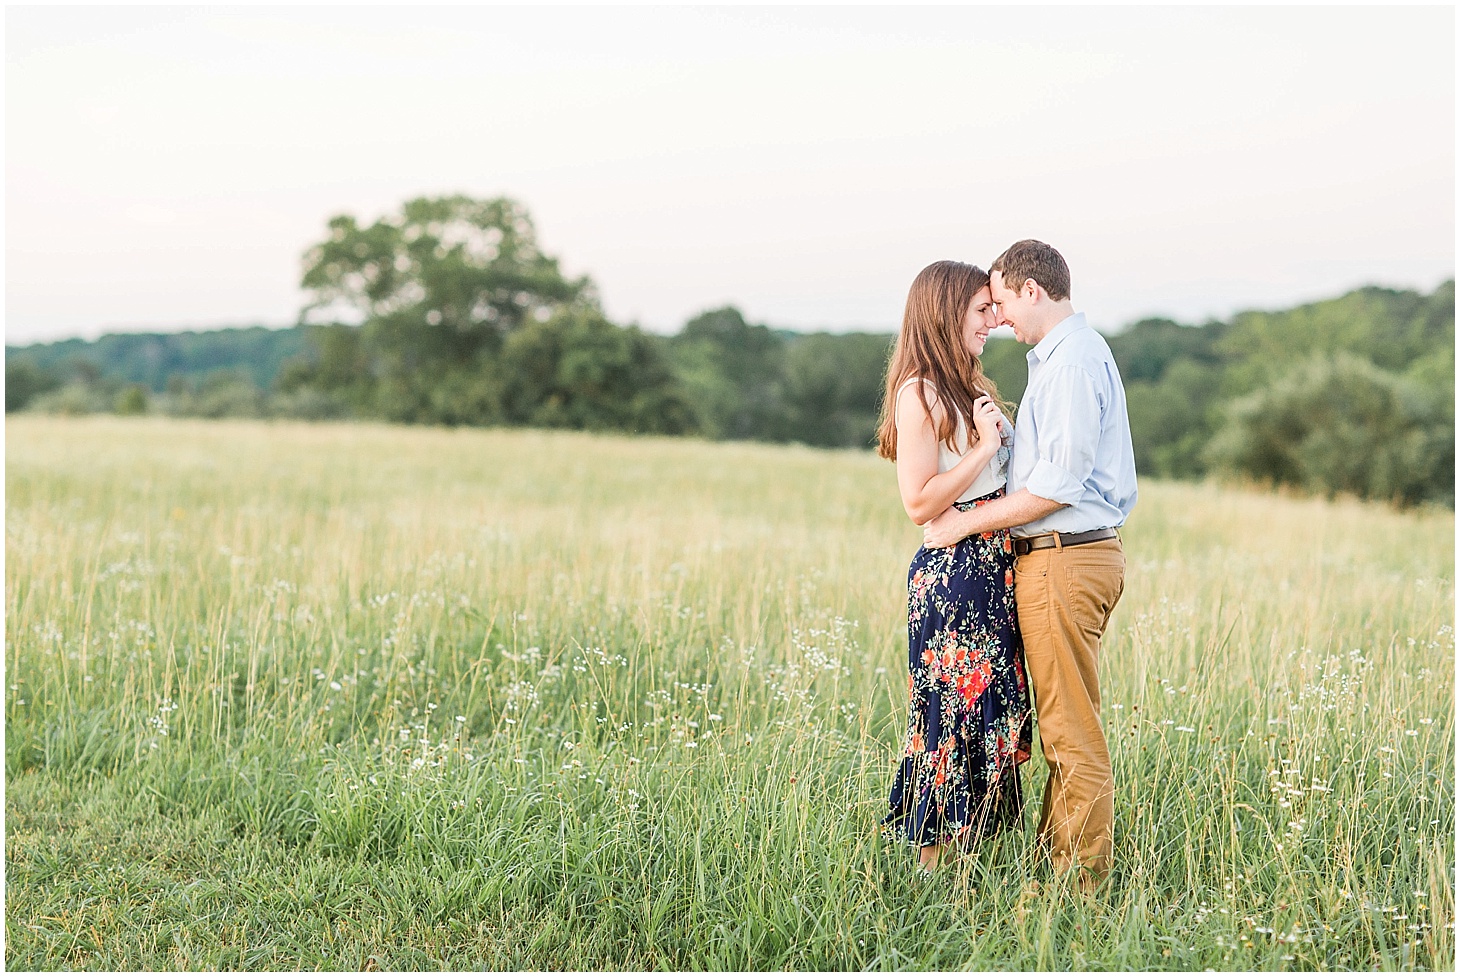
[6,196,1454,507]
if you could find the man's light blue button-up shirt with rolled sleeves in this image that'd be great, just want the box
[1009,313,1136,536]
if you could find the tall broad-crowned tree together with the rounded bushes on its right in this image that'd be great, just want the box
[279,196,706,434]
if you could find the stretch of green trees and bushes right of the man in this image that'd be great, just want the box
[1110,282,1454,504]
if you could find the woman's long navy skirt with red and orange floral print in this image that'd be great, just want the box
[882,491,1031,847]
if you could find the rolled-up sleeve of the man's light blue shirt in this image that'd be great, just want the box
[1025,367,1099,505]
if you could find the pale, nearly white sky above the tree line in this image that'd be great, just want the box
[4,6,1456,343]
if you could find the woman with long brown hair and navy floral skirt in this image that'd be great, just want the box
[877,261,1029,870]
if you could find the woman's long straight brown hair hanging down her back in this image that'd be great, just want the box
[877,261,999,461]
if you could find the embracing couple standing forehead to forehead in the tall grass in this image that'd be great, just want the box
[877,241,1136,889]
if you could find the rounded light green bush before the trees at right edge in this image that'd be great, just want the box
[1209,352,1454,505]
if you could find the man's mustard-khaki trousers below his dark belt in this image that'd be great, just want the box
[1013,539,1126,876]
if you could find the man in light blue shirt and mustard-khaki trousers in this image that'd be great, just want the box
[923,241,1136,891]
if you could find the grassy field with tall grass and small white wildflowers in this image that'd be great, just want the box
[6,416,1456,970]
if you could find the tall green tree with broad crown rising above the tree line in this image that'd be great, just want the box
[289,196,596,422]
